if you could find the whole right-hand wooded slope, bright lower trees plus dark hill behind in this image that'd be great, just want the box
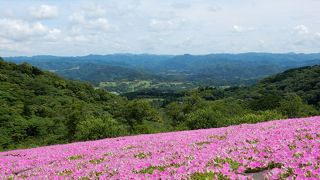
[162,65,320,129]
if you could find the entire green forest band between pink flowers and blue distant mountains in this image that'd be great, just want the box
[0,59,320,151]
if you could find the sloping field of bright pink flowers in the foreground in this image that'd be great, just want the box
[0,117,320,179]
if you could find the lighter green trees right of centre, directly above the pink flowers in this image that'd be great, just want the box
[165,92,319,130]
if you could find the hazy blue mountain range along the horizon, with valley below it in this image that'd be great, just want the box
[4,53,320,86]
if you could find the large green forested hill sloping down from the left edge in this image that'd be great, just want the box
[0,59,164,150]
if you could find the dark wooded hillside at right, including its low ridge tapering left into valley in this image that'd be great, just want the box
[190,65,320,108]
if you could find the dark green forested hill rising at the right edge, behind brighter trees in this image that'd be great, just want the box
[220,65,320,110]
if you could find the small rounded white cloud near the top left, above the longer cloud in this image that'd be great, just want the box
[29,4,59,19]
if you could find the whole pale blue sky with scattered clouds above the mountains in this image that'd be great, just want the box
[0,0,320,56]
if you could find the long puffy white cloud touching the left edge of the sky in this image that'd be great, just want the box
[0,19,61,41]
